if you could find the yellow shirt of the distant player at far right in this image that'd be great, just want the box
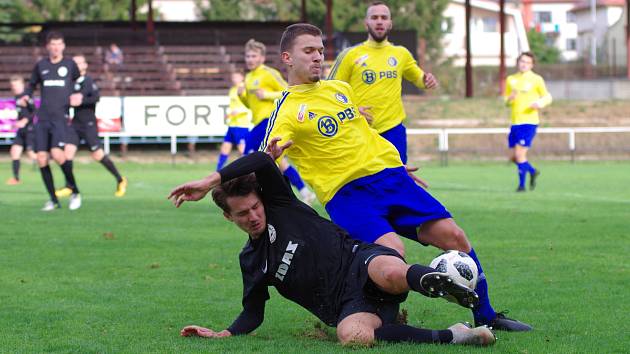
[503,70,552,125]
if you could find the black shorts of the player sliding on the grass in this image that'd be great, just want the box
[337,244,409,324]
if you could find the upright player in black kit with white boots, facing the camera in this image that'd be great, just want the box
[18,32,81,211]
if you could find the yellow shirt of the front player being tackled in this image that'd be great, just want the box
[261,80,403,204]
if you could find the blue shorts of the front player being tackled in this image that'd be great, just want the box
[326,167,451,242]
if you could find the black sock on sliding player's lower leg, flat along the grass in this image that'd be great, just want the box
[374,324,453,343]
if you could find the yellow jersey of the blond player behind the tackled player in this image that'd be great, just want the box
[239,64,287,125]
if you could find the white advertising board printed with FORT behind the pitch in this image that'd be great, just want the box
[123,96,230,136]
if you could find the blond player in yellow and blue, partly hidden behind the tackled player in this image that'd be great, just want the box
[238,39,315,204]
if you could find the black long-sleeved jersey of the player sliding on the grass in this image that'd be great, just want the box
[220,152,365,334]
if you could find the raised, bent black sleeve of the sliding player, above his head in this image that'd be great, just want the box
[219,151,296,204]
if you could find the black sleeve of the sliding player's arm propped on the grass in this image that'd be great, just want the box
[227,254,269,335]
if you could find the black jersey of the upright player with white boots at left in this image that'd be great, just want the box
[25,58,81,120]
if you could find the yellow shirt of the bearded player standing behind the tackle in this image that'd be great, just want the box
[328,40,424,133]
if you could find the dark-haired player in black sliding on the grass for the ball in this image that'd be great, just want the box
[169,139,495,345]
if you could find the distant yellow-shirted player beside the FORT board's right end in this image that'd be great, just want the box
[217,71,252,171]
